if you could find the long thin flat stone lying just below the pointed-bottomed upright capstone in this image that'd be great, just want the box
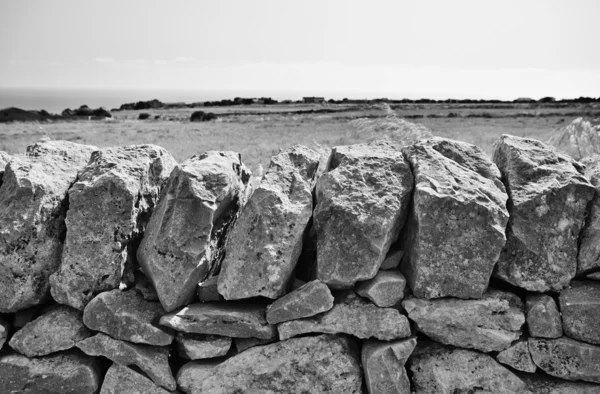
[160,302,277,339]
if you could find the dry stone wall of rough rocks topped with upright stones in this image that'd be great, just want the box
[0,135,600,394]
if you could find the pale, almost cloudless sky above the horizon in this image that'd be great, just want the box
[0,0,600,99]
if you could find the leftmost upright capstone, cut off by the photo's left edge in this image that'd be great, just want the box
[0,141,97,312]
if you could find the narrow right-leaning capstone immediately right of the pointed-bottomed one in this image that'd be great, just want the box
[218,145,319,300]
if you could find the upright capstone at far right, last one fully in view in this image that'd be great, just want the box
[494,135,594,292]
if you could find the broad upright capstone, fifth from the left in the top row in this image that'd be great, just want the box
[313,141,413,288]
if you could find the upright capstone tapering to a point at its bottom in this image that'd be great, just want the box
[137,151,249,312]
